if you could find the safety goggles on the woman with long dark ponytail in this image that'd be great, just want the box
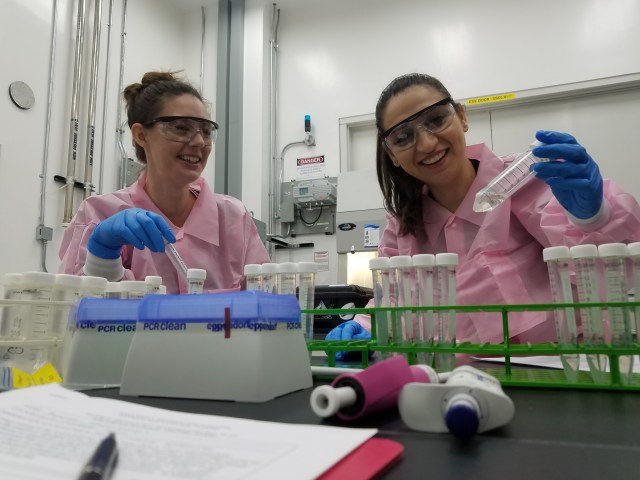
[381,97,456,153]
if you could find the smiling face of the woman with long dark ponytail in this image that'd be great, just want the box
[381,85,469,192]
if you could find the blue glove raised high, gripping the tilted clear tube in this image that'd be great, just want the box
[531,130,603,220]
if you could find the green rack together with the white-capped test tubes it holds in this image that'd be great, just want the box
[303,242,640,390]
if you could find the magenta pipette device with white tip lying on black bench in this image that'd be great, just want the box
[311,355,438,420]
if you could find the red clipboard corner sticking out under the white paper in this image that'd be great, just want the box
[317,437,404,480]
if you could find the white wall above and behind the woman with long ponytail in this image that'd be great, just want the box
[244,0,640,283]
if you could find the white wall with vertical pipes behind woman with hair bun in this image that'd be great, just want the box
[0,0,218,282]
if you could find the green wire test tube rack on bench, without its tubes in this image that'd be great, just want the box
[302,302,640,391]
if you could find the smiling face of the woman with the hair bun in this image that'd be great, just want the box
[131,94,212,188]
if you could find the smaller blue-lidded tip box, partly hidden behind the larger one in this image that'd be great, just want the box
[59,298,142,390]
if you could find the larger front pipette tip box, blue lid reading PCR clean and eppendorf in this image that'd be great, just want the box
[120,291,312,402]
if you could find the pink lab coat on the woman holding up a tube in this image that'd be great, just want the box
[354,144,640,343]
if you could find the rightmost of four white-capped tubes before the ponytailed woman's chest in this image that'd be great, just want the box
[434,253,458,371]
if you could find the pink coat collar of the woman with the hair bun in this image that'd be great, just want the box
[130,171,220,246]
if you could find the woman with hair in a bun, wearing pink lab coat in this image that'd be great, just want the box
[59,72,270,293]
